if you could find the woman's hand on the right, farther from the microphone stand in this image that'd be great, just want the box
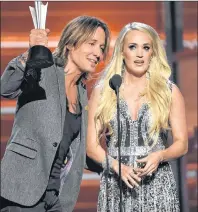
[135,151,163,177]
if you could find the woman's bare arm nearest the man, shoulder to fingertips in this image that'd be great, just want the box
[87,88,141,188]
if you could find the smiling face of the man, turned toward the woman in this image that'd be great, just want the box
[68,27,105,73]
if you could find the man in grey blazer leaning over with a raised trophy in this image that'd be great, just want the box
[1,2,109,212]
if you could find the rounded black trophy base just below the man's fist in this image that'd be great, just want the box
[26,45,54,69]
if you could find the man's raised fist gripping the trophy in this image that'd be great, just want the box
[29,29,50,47]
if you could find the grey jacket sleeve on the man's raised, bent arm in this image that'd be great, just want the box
[1,56,25,99]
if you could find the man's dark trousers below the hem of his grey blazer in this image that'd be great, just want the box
[1,191,62,212]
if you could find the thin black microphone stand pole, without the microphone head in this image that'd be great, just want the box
[115,86,123,212]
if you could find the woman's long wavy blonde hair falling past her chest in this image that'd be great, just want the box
[95,22,171,146]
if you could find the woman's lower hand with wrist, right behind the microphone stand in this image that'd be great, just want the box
[113,163,141,188]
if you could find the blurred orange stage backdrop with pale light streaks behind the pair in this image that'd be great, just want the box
[1,1,198,212]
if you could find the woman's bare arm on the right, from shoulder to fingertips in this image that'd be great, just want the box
[138,85,188,175]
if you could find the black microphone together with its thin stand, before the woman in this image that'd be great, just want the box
[109,74,124,212]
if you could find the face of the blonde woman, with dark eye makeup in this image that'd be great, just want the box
[122,30,153,77]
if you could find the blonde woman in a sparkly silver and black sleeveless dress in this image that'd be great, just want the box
[87,22,188,212]
